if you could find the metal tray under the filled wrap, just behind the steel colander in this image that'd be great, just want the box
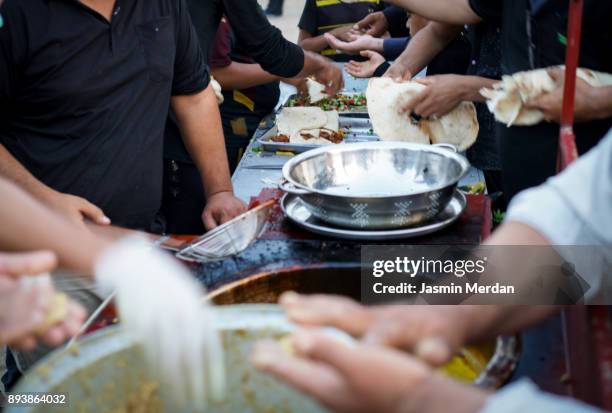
[257,116,380,153]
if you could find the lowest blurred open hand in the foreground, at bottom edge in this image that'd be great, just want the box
[251,331,488,413]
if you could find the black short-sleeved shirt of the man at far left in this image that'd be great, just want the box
[0,0,209,229]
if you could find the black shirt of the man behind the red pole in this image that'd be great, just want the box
[469,0,612,199]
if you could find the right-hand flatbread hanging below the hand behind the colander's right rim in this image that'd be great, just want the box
[421,102,479,152]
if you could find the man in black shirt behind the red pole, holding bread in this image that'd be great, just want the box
[380,0,612,200]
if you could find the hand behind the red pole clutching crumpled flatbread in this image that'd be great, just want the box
[525,68,606,123]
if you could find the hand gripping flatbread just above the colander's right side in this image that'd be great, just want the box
[400,75,464,118]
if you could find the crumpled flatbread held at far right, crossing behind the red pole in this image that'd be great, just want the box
[480,66,612,127]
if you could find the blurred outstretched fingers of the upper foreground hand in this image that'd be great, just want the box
[279,292,372,336]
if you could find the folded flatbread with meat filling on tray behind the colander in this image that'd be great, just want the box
[272,106,344,145]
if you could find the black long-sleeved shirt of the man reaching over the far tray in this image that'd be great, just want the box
[164,0,304,162]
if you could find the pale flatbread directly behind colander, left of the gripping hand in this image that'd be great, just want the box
[366,77,430,144]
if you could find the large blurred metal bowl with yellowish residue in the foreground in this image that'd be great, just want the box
[6,305,327,413]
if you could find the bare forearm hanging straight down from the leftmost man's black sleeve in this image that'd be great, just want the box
[172,86,233,197]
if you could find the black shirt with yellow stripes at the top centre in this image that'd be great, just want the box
[298,0,384,61]
